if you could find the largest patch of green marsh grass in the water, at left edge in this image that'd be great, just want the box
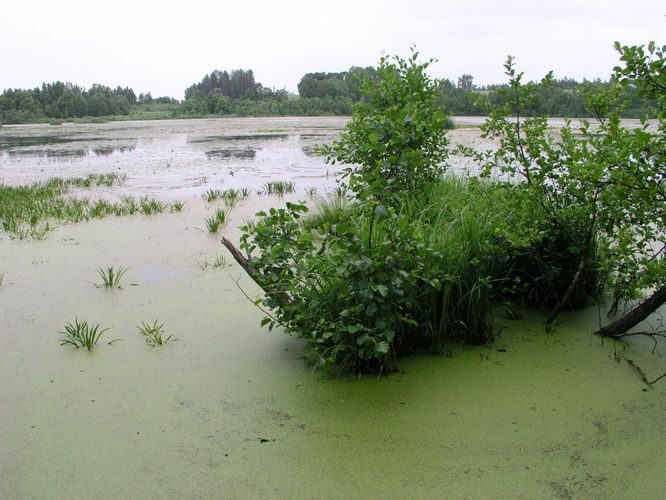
[0,174,182,239]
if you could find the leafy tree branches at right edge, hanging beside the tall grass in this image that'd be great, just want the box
[464,48,666,323]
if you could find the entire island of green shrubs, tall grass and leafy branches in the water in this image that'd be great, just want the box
[223,45,666,373]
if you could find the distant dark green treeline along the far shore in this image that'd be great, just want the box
[0,67,654,124]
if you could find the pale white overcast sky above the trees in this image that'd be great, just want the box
[0,0,666,99]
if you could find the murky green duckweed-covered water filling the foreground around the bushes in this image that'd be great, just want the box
[0,117,666,498]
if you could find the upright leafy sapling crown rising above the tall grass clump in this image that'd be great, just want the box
[322,50,448,203]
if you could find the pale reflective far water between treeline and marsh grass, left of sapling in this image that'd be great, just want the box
[0,117,348,197]
